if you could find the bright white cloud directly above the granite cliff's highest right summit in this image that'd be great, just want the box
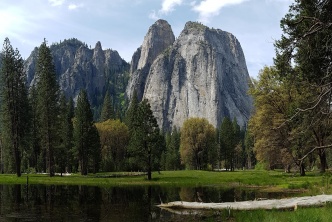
[192,0,248,23]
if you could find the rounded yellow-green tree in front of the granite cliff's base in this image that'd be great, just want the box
[180,118,217,170]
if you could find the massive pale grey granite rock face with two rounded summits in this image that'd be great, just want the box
[127,21,252,130]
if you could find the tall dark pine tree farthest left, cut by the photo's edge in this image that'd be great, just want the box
[0,38,29,176]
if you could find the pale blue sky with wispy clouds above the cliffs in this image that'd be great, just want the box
[0,0,294,78]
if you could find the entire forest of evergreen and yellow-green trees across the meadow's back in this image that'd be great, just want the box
[0,0,332,179]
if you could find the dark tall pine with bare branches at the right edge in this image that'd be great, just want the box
[275,0,332,172]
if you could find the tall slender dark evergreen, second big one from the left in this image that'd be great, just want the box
[36,40,59,177]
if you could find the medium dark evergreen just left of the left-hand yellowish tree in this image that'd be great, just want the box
[74,90,100,175]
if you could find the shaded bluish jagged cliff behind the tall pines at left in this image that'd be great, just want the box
[25,39,129,105]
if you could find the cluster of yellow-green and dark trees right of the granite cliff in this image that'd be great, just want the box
[249,0,332,175]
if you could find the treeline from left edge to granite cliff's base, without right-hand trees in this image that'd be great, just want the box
[0,38,253,179]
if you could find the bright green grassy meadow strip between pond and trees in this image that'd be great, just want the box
[0,170,332,194]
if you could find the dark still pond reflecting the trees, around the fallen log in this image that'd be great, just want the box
[0,185,296,222]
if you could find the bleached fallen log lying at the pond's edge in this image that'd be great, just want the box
[158,195,332,210]
